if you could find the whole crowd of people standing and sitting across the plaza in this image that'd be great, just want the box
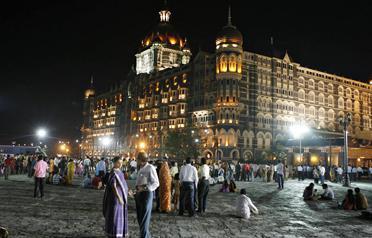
[0,152,368,237]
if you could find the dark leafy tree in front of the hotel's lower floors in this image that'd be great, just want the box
[164,128,200,159]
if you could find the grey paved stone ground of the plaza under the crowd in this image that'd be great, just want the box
[0,175,372,238]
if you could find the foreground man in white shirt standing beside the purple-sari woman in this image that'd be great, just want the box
[135,152,159,237]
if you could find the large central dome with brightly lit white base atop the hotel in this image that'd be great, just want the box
[136,1,191,74]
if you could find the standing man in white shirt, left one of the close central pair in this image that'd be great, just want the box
[179,158,199,217]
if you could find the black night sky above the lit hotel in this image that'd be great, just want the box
[0,0,372,144]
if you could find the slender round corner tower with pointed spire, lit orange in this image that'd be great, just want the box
[215,7,243,159]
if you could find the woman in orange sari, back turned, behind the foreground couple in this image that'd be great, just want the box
[159,161,172,212]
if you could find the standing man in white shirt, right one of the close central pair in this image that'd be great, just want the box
[197,157,210,213]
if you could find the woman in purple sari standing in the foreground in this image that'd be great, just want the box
[103,157,129,238]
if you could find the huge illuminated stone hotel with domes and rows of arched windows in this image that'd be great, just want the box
[83,5,372,163]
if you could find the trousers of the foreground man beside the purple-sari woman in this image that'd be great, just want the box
[136,191,154,238]
